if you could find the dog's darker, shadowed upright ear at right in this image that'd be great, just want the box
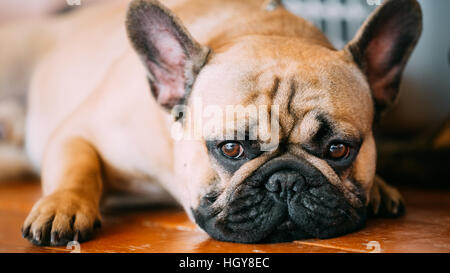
[345,0,422,113]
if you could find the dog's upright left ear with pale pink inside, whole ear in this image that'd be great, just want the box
[126,0,209,109]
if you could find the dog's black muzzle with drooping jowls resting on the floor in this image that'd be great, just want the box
[193,159,366,243]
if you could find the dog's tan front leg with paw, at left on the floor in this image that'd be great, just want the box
[22,138,102,245]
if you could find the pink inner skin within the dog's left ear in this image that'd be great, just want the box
[147,26,186,107]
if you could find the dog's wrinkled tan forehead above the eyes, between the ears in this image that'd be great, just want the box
[191,37,373,134]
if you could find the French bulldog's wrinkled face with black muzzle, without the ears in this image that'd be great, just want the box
[183,41,375,242]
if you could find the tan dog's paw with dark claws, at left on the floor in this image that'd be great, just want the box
[22,191,100,246]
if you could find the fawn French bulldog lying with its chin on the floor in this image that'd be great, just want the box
[15,0,422,245]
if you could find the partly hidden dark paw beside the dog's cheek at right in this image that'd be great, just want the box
[369,176,405,217]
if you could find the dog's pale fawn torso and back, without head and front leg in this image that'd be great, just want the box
[26,1,331,206]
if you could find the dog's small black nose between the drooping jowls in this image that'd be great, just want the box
[266,170,305,198]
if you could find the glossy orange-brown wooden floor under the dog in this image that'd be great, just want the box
[0,182,450,253]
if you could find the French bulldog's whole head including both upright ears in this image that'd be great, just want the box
[128,0,421,242]
